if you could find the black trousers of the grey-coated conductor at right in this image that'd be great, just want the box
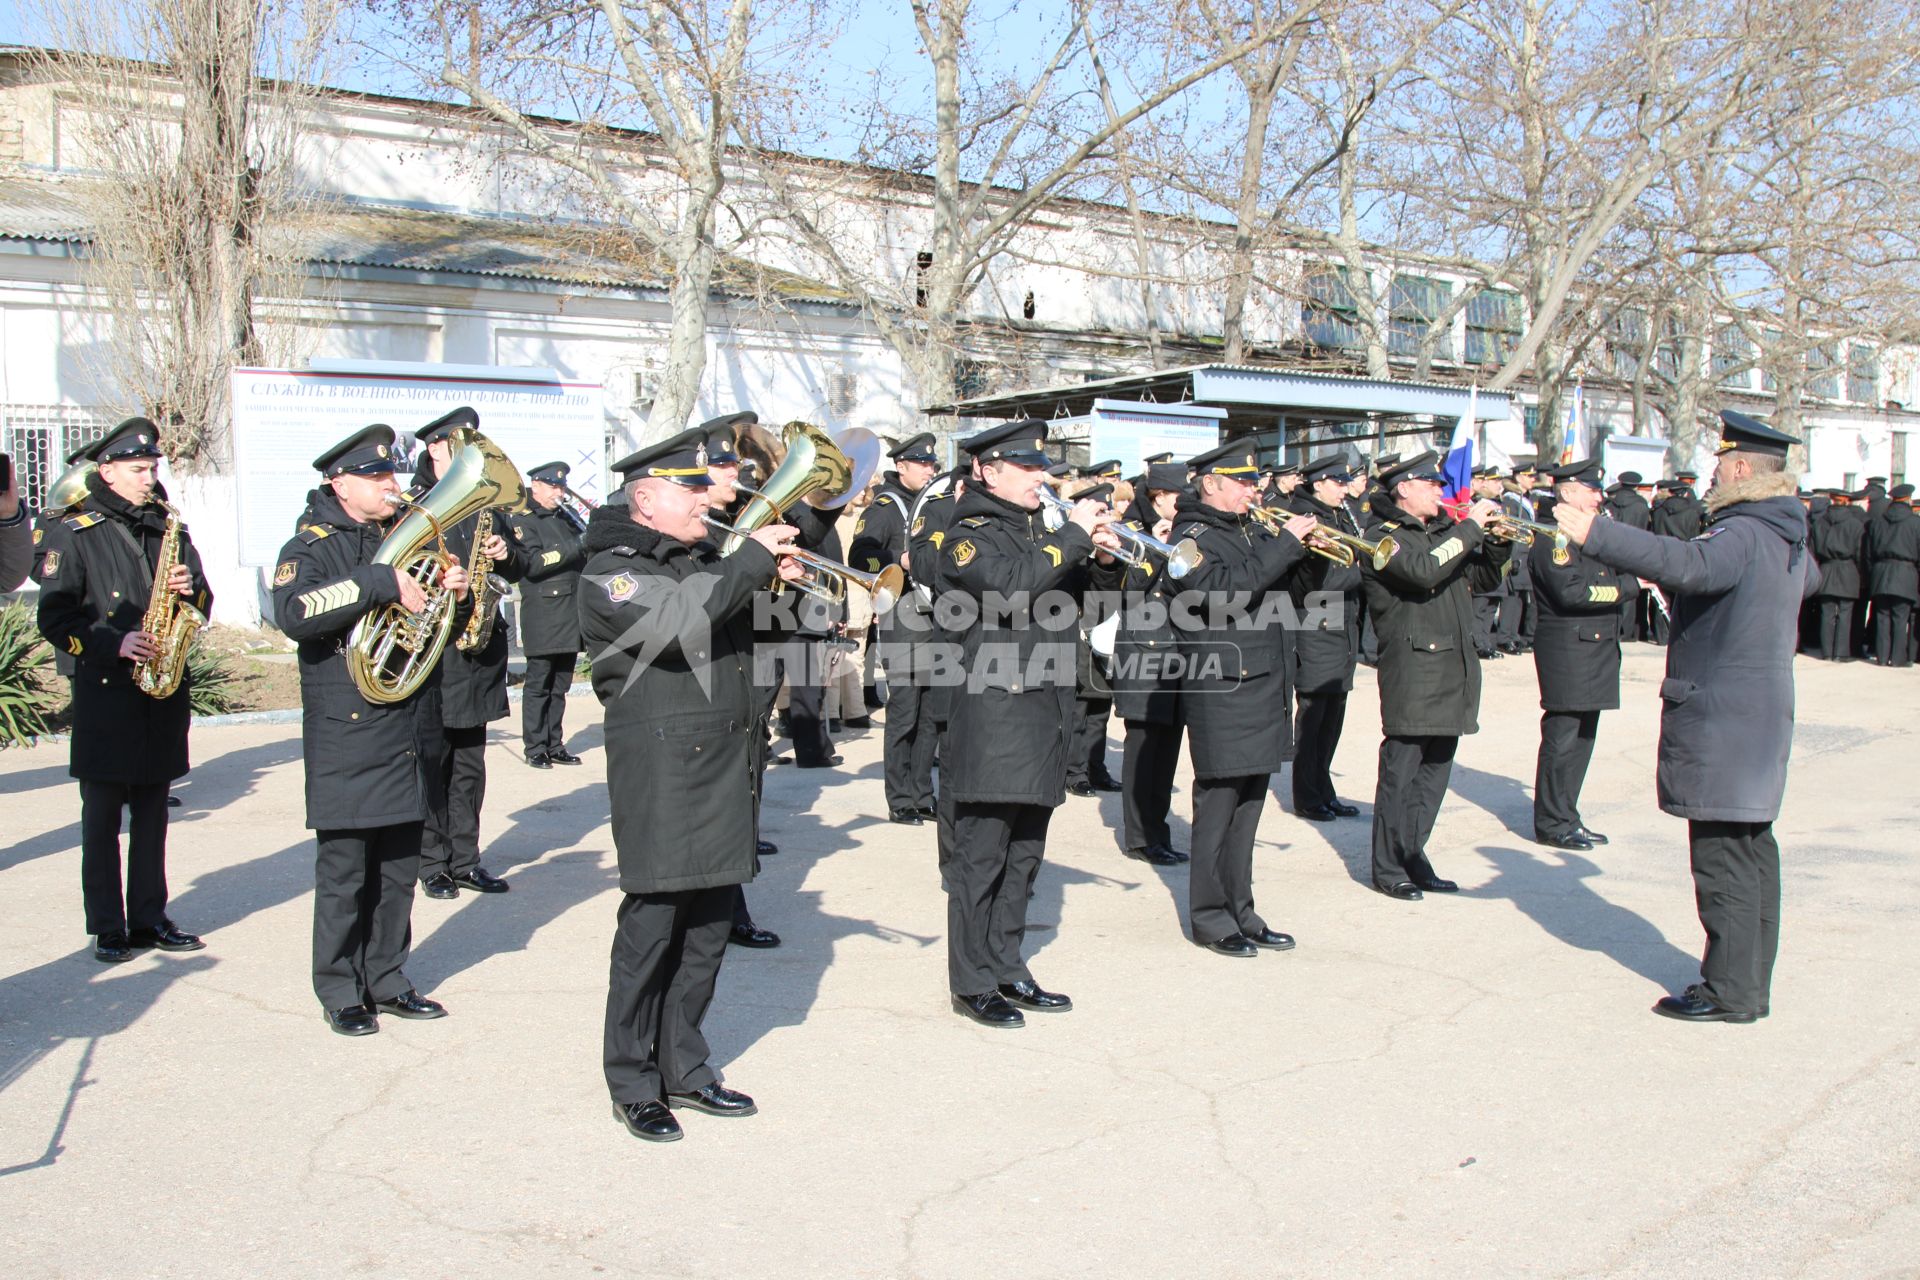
[1686,821,1780,1013]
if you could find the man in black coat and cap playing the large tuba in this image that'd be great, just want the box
[273,424,470,1036]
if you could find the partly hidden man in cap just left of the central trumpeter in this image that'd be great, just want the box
[847,432,941,827]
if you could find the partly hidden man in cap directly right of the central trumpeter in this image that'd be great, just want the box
[1112,462,1187,867]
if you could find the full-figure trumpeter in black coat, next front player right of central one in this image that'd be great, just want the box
[1173,439,1313,958]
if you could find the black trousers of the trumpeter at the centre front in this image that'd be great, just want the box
[941,802,1054,996]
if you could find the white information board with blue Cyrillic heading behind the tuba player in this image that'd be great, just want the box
[232,368,607,568]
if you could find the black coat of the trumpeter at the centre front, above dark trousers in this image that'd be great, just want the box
[916,491,1092,808]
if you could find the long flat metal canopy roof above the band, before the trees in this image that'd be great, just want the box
[927,365,1513,445]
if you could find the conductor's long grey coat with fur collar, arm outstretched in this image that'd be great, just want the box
[1584,472,1816,821]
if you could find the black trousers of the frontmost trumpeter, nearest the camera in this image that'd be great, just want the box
[601,885,739,1103]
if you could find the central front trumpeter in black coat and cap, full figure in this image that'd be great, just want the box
[935,420,1116,1027]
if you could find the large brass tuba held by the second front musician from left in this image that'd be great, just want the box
[348,426,526,704]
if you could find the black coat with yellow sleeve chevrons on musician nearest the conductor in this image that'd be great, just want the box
[1526,537,1632,712]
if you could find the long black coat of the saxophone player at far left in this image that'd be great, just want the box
[35,476,213,785]
